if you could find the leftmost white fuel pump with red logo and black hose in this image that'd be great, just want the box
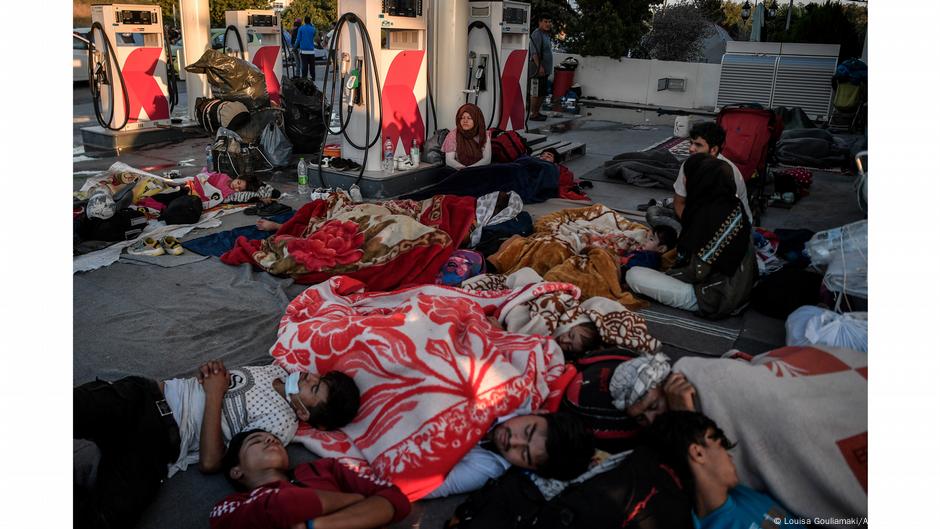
[88,4,178,131]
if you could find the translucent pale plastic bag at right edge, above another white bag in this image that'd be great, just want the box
[806,220,868,298]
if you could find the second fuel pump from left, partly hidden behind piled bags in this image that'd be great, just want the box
[223,9,284,105]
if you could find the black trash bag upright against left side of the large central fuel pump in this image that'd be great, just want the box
[281,77,330,153]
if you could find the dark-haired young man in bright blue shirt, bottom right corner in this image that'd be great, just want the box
[650,411,803,529]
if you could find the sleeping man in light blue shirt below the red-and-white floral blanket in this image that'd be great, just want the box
[426,410,594,498]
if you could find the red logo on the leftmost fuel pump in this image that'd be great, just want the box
[121,48,170,122]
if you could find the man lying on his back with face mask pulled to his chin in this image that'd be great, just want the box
[72,360,359,527]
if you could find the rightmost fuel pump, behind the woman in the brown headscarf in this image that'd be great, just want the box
[466,0,531,130]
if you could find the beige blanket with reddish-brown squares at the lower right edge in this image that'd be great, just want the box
[674,347,868,518]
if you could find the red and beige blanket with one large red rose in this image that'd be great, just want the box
[221,192,475,290]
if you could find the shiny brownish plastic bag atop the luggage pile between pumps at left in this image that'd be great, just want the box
[186,50,271,110]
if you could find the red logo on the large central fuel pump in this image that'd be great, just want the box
[381,51,424,151]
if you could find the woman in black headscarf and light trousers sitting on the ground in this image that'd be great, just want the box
[624,153,757,318]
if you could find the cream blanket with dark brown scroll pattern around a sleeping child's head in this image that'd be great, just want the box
[461,268,660,353]
